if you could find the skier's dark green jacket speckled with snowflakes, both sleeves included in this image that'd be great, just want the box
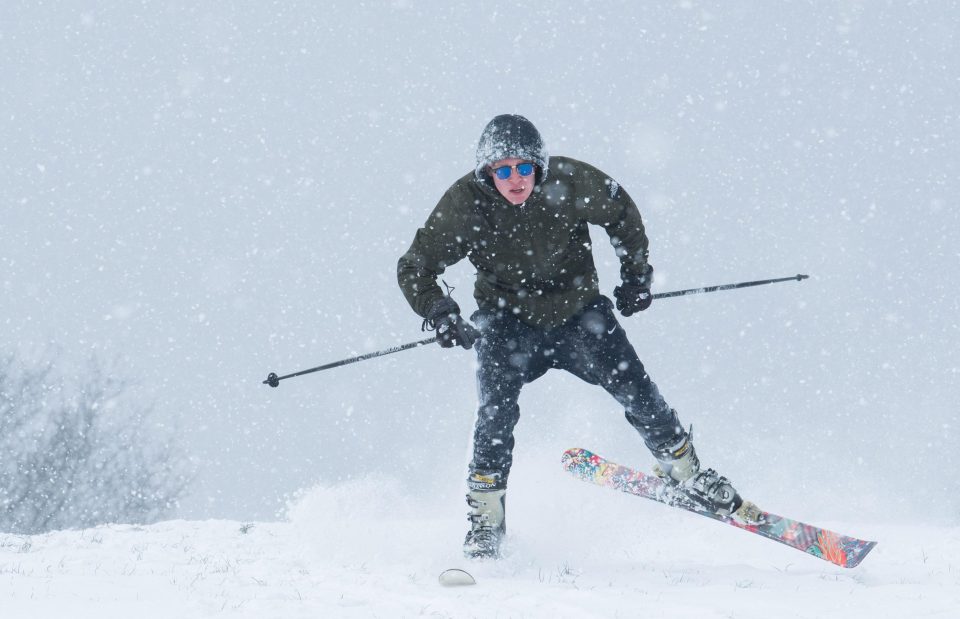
[397,157,647,328]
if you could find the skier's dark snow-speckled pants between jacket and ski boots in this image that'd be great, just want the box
[468,296,686,490]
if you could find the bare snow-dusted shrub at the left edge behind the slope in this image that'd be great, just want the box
[0,356,191,534]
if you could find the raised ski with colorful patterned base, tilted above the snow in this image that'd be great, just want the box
[563,448,877,567]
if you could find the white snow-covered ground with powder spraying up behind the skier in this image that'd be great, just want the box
[0,476,960,619]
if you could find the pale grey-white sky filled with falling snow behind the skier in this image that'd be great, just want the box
[0,0,960,519]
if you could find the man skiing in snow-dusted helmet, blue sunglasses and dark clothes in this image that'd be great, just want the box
[397,114,742,558]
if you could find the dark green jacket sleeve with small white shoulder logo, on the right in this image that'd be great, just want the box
[578,165,650,285]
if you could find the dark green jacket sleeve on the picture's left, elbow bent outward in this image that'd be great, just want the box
[397,185,472,317]
